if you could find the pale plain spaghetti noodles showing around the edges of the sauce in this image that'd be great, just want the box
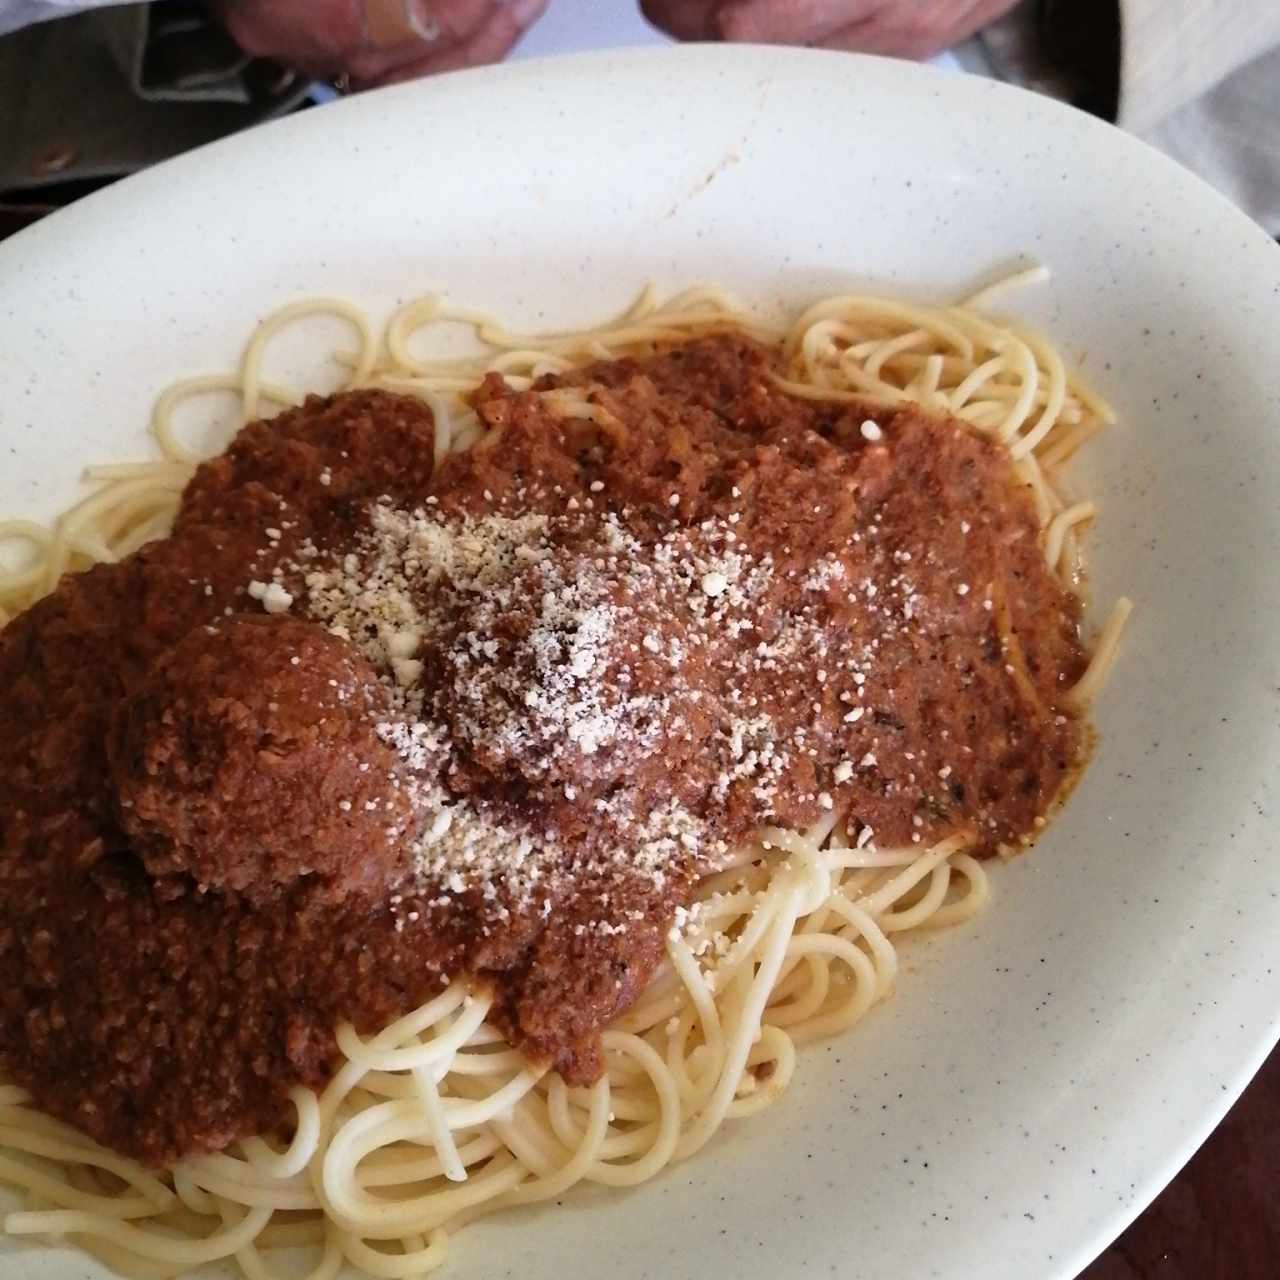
[0,271,1129,1280]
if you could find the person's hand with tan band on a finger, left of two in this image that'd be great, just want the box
[216,0,547,88]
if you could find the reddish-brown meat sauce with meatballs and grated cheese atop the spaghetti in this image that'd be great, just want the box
[0,335,1085,1165]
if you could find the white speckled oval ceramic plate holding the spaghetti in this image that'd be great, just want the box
[0,40,1280,1280]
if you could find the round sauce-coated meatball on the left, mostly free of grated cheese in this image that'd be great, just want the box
[108,616,412,901]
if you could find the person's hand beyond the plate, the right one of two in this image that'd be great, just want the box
[640,0,1018,58]
